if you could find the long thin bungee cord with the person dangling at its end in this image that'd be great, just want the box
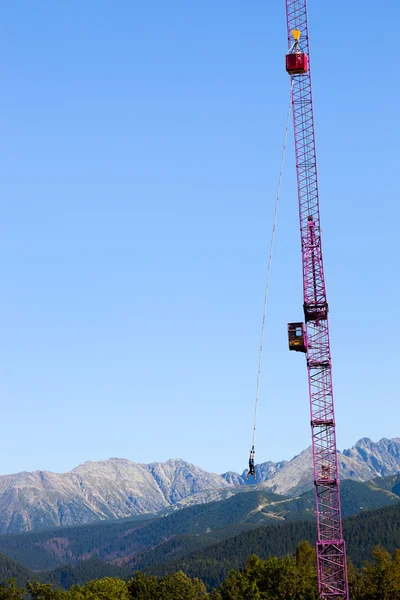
[248,82,293,477]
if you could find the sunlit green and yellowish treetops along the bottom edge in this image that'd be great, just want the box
[0,542,400,600]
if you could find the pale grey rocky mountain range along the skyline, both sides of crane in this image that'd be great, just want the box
[0,438,400,533]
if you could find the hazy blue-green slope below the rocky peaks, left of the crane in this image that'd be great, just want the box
[0,491,298,570]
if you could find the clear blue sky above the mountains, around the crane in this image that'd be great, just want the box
[0,0,400,473]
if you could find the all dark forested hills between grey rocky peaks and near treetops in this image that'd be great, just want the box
[0,475,400,587]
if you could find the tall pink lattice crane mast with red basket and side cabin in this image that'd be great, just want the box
[286,0,349,600]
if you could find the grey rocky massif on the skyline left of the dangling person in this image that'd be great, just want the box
[0,458,229,533]
